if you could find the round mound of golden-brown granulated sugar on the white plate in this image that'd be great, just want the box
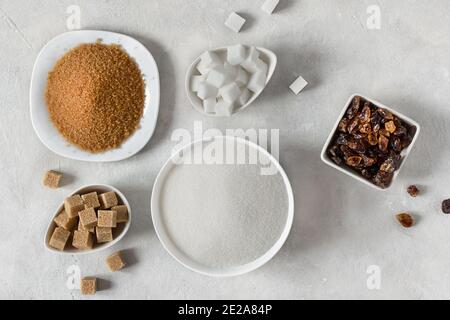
[45,42,145,153]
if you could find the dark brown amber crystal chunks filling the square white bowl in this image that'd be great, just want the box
[328,96,416,188]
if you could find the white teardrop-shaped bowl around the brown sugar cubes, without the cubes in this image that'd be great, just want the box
[44,184,131,255]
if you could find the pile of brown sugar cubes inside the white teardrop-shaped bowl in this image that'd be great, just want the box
[49,191,128,251]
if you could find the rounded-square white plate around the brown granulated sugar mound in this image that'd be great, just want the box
[30,30,160,161]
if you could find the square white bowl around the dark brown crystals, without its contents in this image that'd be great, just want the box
[320,94,420,191]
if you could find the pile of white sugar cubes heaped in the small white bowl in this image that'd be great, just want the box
[190,44,268,116]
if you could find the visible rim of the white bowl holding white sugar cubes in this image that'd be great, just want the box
[185,47,277,117]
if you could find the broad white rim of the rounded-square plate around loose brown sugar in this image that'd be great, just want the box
[29,30,161,162]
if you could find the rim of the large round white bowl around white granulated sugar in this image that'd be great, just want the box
[151,136,294,277]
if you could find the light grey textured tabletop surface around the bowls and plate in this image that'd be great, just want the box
[0,0,450,299]
